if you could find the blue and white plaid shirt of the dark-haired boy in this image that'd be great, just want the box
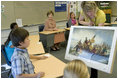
[11,48,34,77]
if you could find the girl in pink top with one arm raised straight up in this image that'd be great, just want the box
[67,4,78,27]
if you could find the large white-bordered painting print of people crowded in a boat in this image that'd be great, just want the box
[65,26,117,73]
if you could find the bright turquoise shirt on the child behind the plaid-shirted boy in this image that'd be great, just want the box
[5,41,15,61]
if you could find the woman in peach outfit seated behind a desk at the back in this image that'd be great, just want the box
[44,11,65,51]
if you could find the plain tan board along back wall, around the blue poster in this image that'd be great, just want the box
[1,1,67,29]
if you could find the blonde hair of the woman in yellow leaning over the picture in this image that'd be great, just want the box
[81,1,99,21]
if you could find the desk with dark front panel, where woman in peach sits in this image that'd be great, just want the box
[39,29,65,52]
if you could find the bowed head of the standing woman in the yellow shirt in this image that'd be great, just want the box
[81,1,99,19]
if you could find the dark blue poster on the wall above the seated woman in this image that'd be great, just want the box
[55,1,67,12]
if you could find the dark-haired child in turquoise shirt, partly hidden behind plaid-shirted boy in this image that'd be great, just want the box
[5,23,18,61]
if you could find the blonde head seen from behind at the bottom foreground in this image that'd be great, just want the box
[64,60,89,78]
